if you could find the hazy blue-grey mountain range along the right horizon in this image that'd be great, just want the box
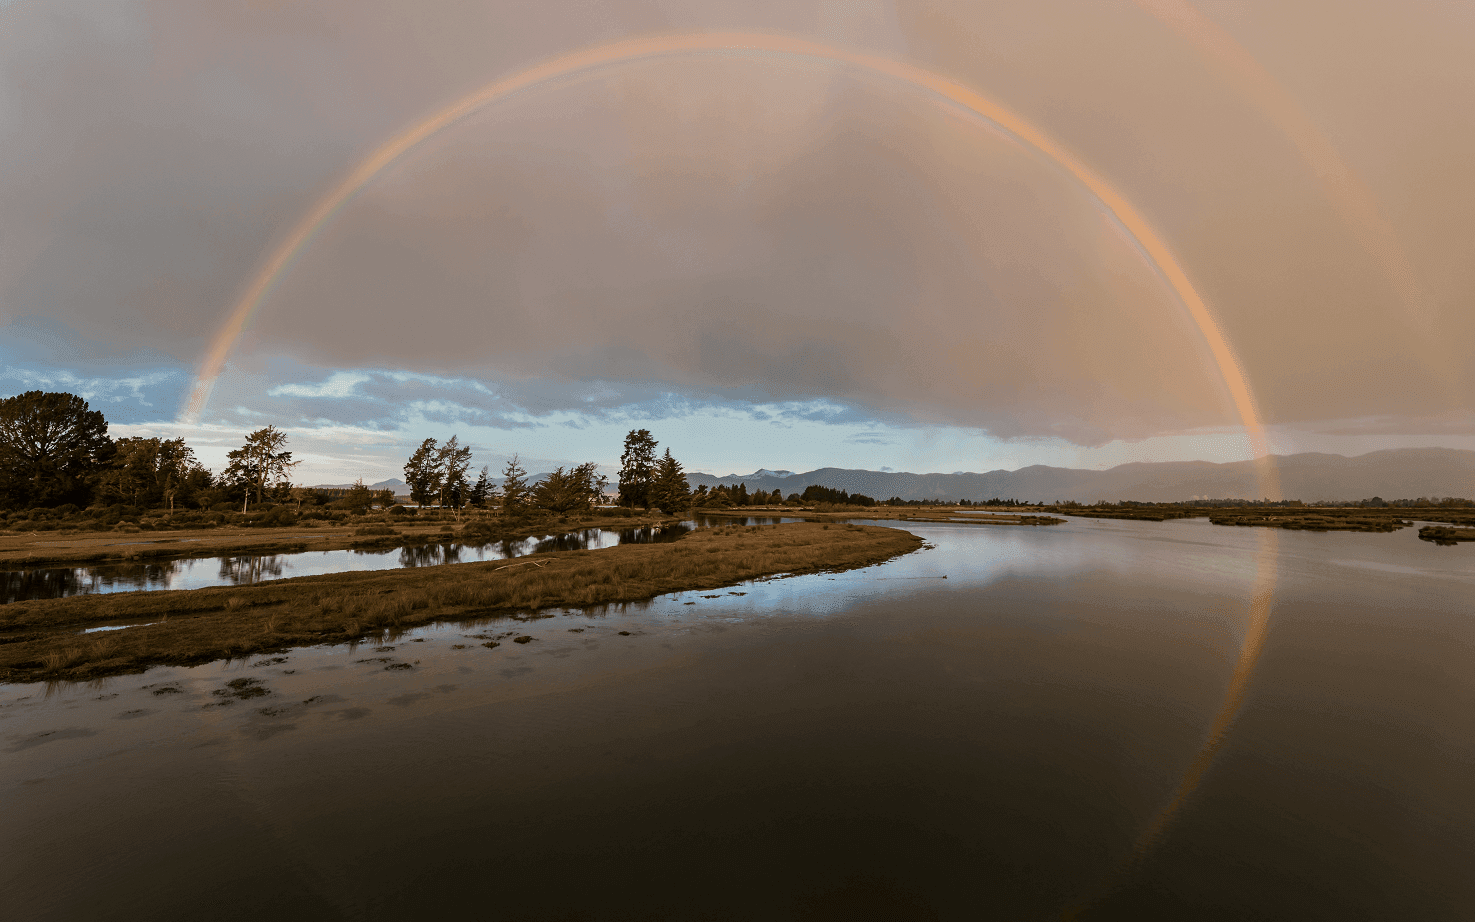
[686,448,1475,503]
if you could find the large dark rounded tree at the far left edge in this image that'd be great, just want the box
[0,391,112,507]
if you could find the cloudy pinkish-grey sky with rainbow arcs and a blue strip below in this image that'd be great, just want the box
[0,0,1475,484]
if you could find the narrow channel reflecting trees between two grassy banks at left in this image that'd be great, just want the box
[0,516,707,602]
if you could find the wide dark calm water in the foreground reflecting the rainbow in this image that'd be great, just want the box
[0,521,1475,922]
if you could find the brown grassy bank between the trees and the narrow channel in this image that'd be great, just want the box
[0,509,676,569]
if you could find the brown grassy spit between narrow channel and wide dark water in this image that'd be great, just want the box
[0,522,922,682]
